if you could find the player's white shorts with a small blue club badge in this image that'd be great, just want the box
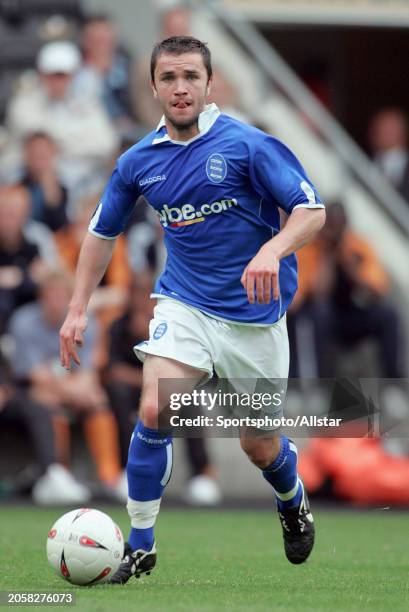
[134,297,289,429]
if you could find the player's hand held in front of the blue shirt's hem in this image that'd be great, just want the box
[240,247,280,304]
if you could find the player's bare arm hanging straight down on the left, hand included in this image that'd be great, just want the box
[60,234,115,369]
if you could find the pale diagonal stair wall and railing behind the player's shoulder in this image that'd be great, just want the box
[195,3,409,272]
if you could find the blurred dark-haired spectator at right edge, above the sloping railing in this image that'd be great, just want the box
[368,108,409,203]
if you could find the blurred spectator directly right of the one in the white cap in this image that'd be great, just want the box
[74,15,135,133]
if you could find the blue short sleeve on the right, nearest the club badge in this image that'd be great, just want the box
[250,135,324,214]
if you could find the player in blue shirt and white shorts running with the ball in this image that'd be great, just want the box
[60,37,325,584]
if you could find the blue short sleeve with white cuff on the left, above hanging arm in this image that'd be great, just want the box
[88,167,139,240]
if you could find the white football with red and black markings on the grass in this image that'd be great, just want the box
[47,508,124,586]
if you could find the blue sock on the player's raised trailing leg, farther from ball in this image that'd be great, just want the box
[263,434,303,510]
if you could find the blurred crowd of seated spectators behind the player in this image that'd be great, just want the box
[0,1,409,505]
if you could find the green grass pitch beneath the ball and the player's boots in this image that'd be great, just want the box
[0,507,409,612]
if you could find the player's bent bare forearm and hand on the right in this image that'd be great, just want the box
[241,208,325,304]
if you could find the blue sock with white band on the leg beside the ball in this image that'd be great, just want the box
[126,421,172,550]
